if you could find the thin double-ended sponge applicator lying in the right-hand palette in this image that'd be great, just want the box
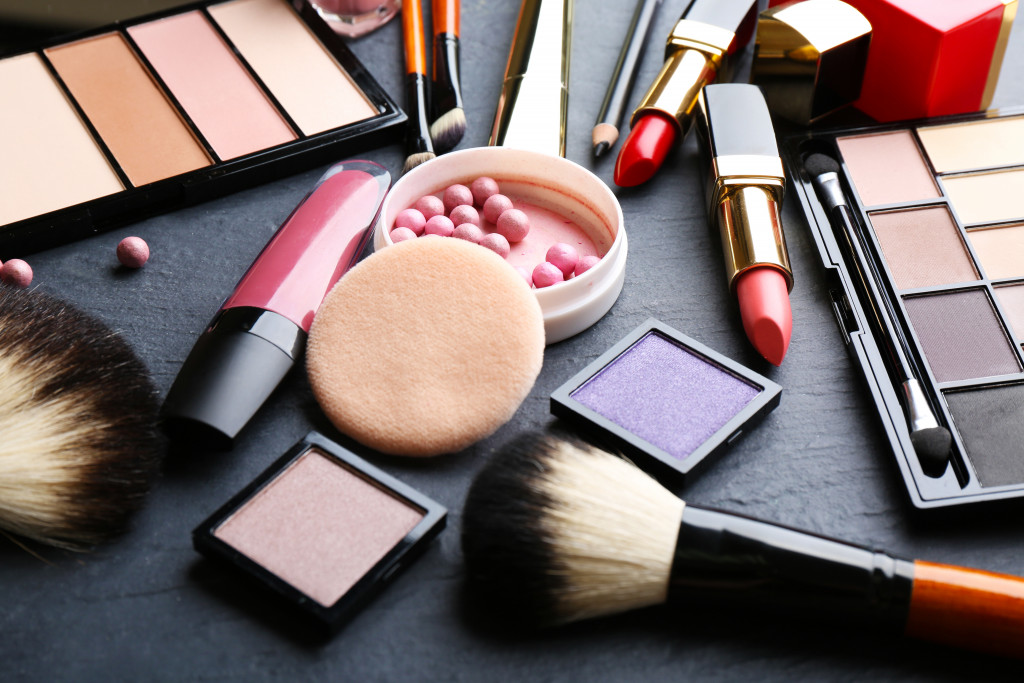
[804,154,952,476]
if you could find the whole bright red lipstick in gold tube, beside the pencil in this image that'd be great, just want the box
[614,0,757,187]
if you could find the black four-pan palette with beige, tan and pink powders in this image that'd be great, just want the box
[0,0,406,254]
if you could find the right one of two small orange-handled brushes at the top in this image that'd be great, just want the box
[430,0,466,154]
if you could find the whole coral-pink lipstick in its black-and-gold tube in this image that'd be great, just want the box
[696,83,793,366]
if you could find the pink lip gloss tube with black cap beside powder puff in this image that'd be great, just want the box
[161,161,391,450]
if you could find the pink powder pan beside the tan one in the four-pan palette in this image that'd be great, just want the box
[128,10,295,159]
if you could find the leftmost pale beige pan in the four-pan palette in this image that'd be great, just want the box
[0,53,123,224]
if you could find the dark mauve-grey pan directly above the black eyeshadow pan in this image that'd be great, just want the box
[904,289,1021,382]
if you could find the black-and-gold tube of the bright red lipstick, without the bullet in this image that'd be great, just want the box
[631,0,757,139]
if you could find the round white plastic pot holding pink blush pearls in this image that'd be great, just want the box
[374,146,627,344]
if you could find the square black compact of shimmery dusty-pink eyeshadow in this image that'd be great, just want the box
[193,432,446,633]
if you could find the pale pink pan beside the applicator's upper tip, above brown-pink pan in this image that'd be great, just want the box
[836,130,941,206]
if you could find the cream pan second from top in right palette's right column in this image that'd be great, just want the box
[942,171,1024,223]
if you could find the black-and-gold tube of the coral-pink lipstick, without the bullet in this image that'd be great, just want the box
[696,83,793,290]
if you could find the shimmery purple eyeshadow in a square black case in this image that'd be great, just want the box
[551,319,782,485]
